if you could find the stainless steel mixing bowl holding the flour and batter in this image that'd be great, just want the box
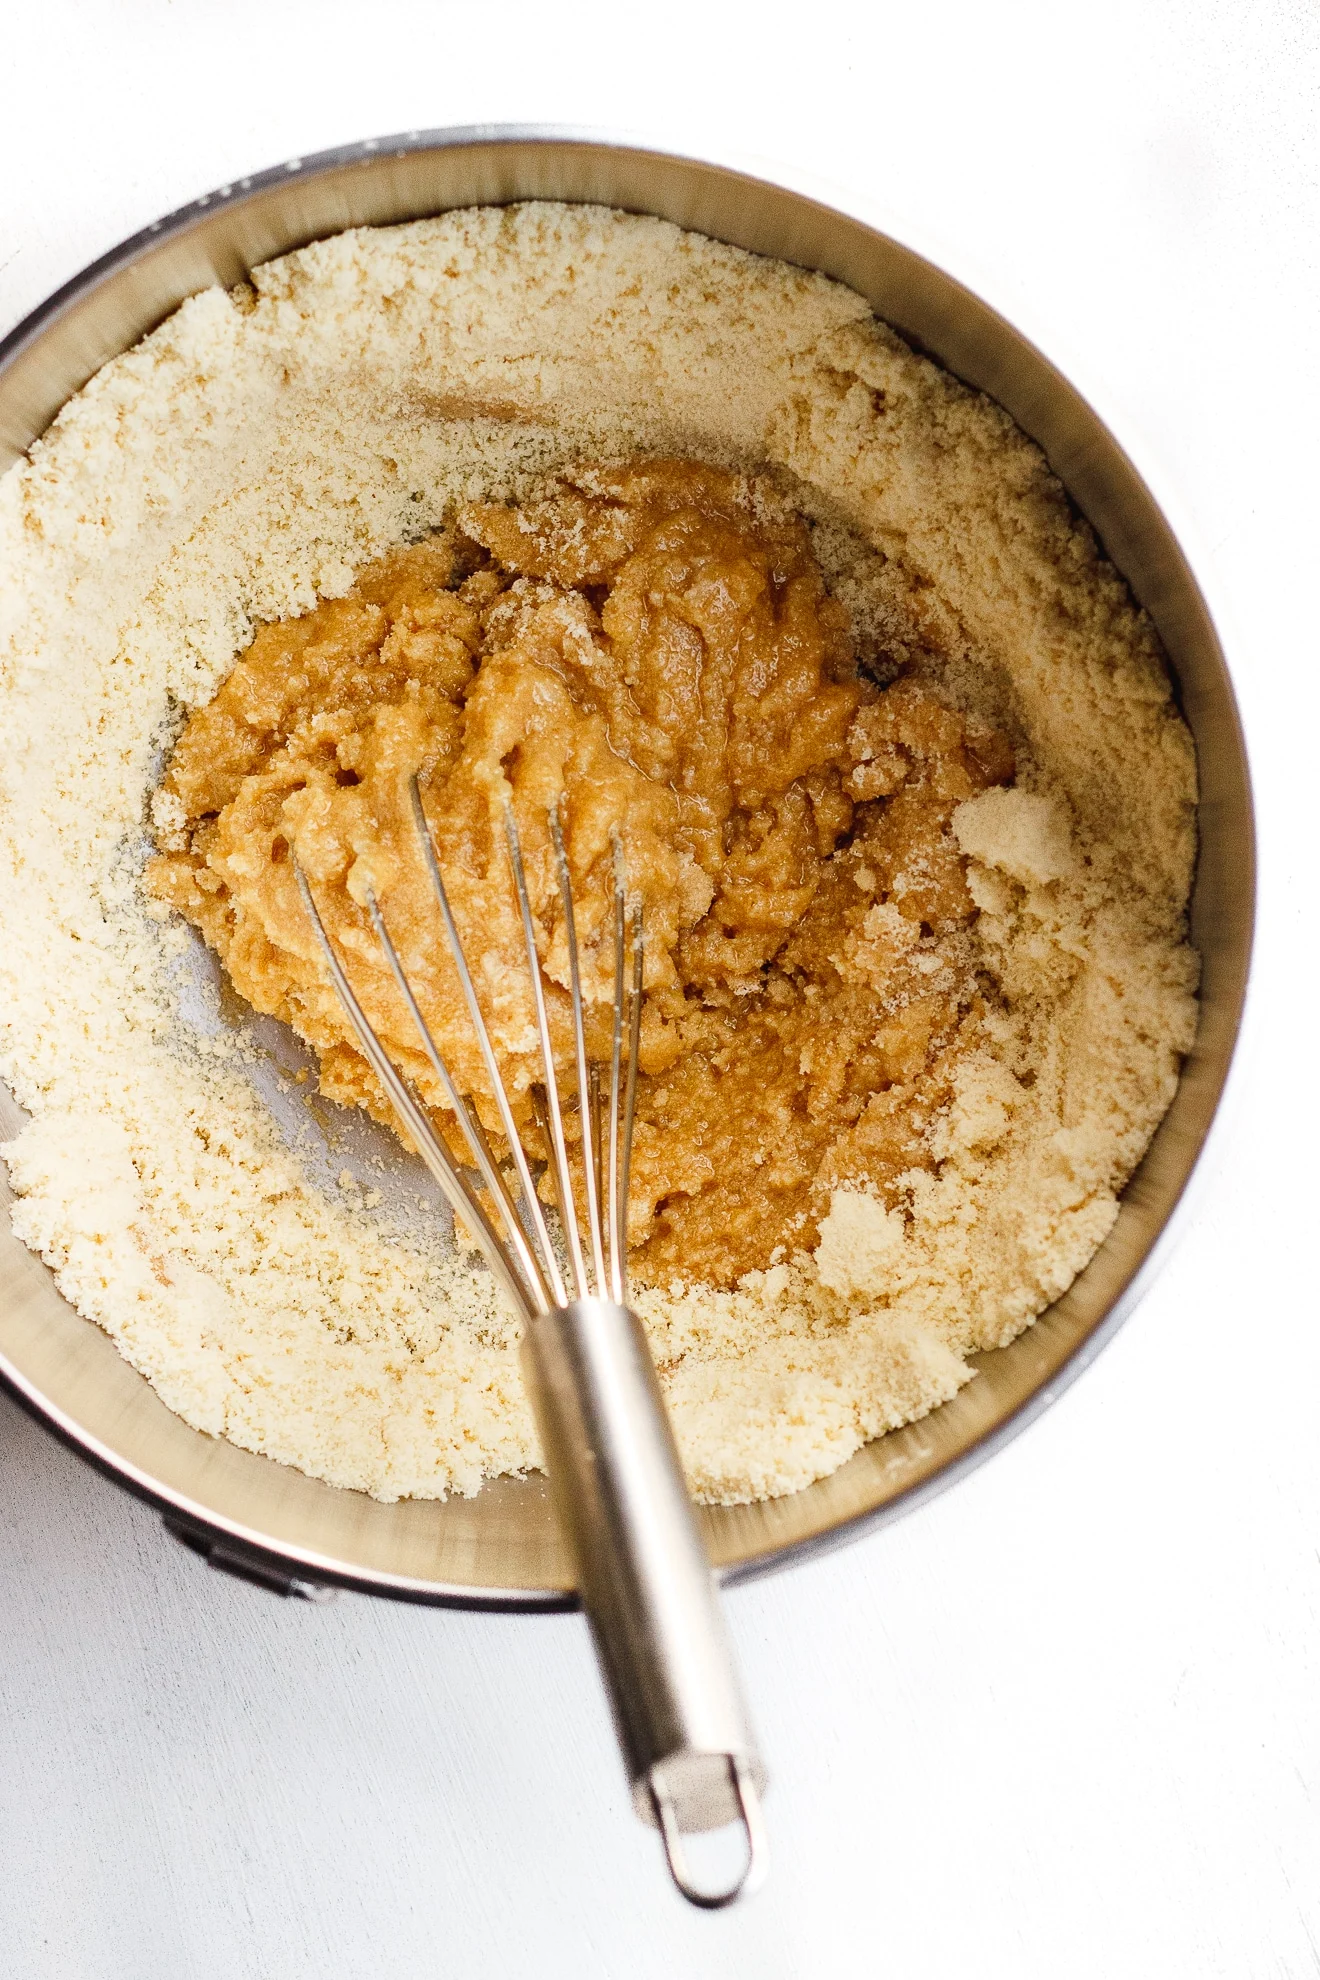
[0,129,1255,1608]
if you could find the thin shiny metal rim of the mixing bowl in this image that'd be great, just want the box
[0,123,1257,1614]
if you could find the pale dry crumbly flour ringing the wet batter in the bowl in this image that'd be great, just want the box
[0,206,1195,1503]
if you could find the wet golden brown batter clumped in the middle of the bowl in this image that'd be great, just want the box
[146,461,1013,1285]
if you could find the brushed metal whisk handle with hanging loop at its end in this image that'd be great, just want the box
[524,1299,764,1903]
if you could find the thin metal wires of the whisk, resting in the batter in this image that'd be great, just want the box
[293,776,645,1317]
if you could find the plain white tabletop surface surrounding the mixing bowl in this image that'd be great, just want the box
[0,0,1320,1980]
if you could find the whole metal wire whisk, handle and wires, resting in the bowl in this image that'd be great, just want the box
[293,776,766,1909]
